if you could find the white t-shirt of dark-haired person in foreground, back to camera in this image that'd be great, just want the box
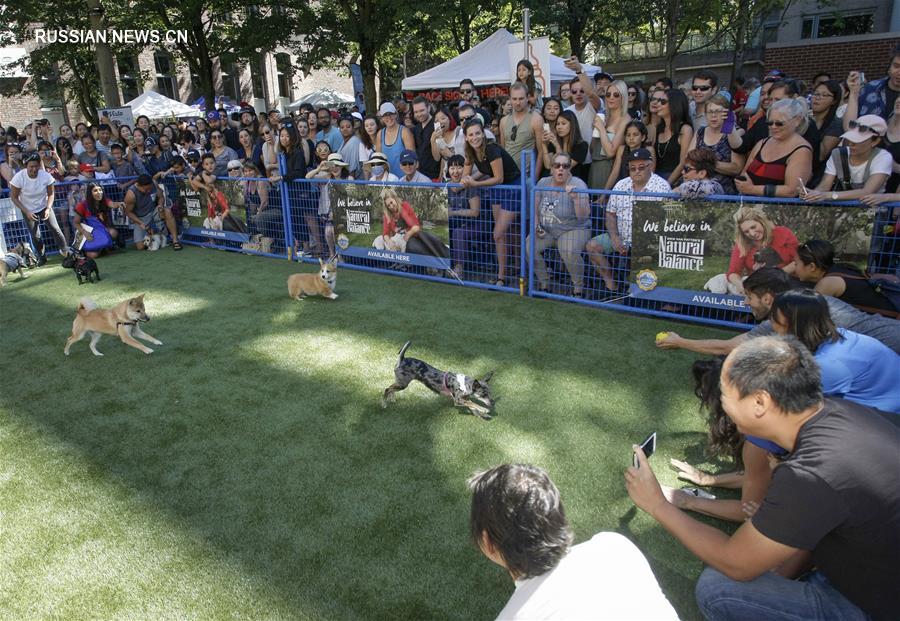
[497,533,678,621]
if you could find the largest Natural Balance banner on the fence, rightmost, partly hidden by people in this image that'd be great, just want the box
[630,201,877,310]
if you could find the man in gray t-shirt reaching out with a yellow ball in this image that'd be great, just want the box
[656,267,900,356]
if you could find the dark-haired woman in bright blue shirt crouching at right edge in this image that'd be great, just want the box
[769,289,900,414]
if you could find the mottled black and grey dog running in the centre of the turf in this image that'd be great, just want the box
[381,341,494,420]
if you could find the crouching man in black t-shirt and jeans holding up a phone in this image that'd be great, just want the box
[625,336,900,621]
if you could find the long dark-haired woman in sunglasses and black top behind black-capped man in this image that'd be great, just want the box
[653,88,694,186]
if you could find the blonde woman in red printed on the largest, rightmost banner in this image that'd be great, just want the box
[704,207,798,295]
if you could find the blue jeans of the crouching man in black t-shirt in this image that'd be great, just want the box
[695,567,869,621]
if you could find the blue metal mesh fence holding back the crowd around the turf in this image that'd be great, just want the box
[0,161,900,328]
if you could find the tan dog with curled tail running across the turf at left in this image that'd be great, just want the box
[63,293,162,356]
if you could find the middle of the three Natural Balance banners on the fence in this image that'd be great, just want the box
[323,179,450,270]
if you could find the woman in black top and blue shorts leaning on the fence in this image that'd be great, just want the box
[461,119,520,286]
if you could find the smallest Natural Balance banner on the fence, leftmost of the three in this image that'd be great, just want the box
[172,178,250,243]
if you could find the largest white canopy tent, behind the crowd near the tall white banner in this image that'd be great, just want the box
[401,28,600,95]
